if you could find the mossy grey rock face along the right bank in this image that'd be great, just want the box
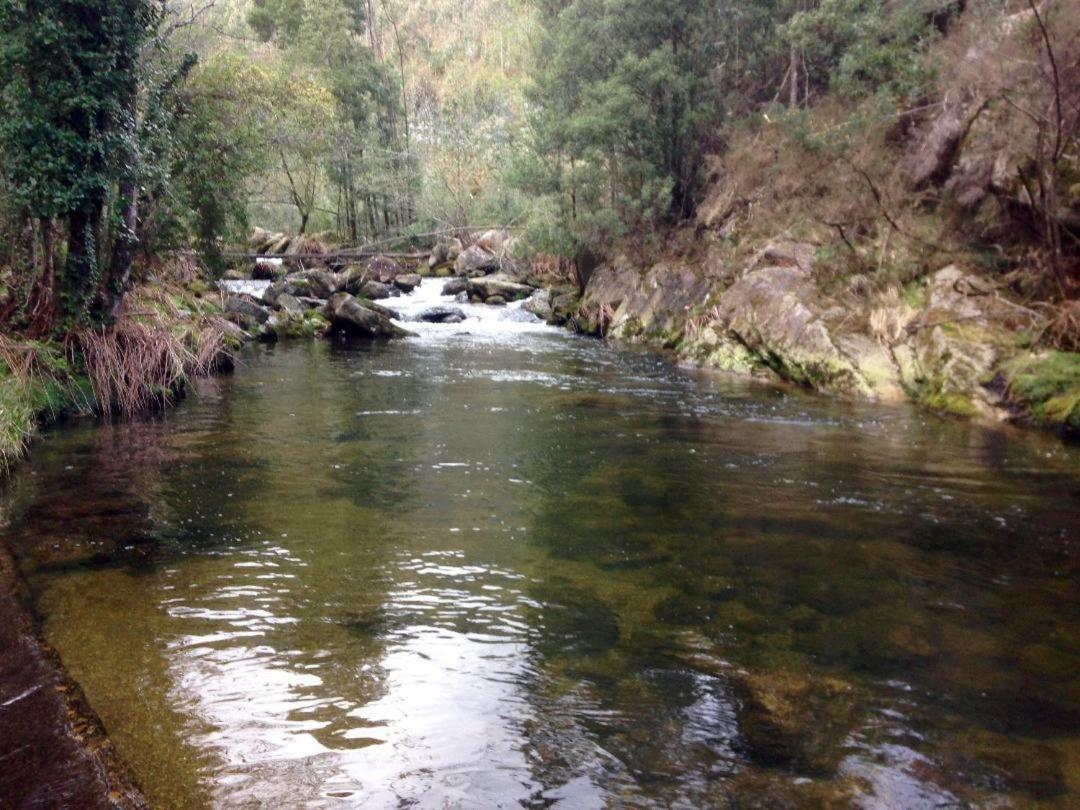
[578,242,1076,429]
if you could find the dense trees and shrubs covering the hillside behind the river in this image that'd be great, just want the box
[0,0,1077,334]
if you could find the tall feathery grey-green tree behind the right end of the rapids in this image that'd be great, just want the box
[518,0,721,258]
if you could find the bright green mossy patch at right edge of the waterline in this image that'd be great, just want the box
[1002,352,1080,430]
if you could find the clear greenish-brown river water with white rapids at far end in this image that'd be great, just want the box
[3,282,1080,808]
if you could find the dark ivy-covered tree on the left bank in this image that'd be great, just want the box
[0,0,161,334]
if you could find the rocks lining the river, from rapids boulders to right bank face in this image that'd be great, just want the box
[219,231,1080,435]
